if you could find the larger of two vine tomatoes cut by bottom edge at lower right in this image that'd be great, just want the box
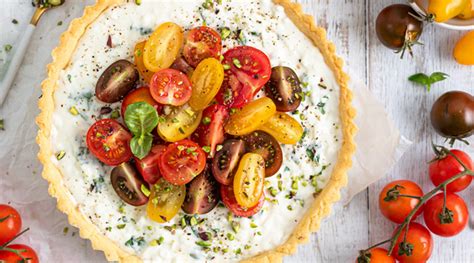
[392,222,433,263]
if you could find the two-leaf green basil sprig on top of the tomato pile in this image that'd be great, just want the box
[124,102,158,159]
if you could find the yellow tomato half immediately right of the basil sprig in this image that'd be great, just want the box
[157,104,202,142]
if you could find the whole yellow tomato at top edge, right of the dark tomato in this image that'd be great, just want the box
[428,0,471,22]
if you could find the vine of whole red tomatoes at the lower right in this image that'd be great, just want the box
[357,148,474,263]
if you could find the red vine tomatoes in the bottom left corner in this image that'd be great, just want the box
[0,204,39,263]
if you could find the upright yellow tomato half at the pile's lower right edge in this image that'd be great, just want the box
[233,153,265,208]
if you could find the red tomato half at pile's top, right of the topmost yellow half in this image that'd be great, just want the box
[183,26,222,67]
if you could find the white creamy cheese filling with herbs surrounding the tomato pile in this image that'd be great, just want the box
[51,0,342,262]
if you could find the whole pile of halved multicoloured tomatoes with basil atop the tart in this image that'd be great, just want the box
[86,23,303,222]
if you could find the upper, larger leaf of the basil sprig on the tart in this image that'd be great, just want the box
[124,102,158,136]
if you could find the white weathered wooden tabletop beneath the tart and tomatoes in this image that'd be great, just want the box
[0,0,474,262]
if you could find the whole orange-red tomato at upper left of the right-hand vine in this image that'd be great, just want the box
[379,180,423,224]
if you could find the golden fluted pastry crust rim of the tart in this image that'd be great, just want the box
[36,0,356,262]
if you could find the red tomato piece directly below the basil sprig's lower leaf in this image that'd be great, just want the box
[134,145,166,184]
